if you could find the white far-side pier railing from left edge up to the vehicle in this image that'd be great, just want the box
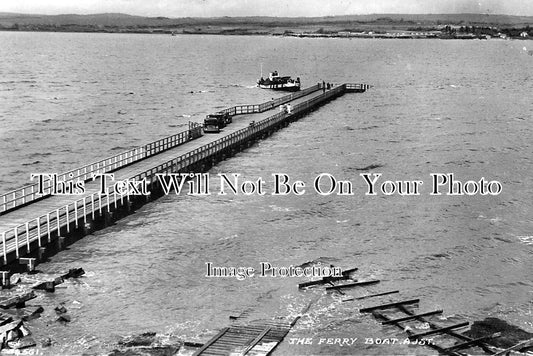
[0,123,201,215]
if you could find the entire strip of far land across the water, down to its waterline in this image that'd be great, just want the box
[0,13,533,39]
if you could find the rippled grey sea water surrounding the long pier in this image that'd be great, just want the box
[0,32,533,355]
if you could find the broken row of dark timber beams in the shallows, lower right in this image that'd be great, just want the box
[298,268,533,356]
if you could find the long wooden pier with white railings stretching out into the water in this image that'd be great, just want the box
[0,84,368,276]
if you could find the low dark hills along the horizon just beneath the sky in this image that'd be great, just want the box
[0,13,533,34]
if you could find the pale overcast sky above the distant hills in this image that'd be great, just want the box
[0,0,533,17]
